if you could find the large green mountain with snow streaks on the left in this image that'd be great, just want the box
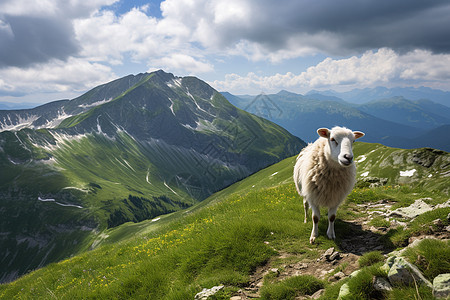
[0,71,305,282]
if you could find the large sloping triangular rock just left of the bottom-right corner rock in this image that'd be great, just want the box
[388,257,432,288]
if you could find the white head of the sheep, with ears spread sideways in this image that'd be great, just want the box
[317,127,364,167]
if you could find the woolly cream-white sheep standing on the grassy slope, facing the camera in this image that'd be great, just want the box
[294,127,364,244]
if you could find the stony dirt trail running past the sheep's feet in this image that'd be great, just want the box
[198,199,450,300]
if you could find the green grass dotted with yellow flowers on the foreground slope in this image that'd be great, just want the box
[0,143,448,299]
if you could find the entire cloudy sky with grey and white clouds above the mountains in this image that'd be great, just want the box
[0,0,450,103]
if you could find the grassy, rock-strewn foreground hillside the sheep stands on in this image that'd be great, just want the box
[0,142,450,300]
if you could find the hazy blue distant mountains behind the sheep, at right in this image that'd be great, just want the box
[222,88,450,151]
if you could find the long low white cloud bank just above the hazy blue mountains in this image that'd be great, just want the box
[211,48,450,93]
